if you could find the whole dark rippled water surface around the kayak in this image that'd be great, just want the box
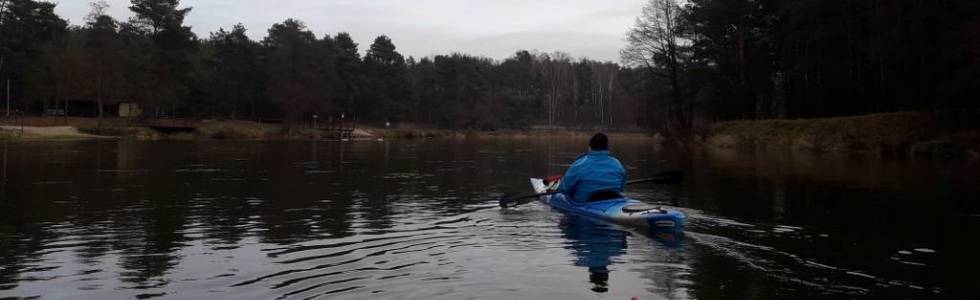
[0,139,980,299]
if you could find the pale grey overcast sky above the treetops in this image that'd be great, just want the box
[57,0,645,62]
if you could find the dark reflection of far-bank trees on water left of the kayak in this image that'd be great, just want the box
[0,135,660,294]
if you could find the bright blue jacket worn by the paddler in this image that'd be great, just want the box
[558,151,626,203]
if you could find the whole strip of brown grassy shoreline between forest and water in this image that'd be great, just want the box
[0,112,980,160]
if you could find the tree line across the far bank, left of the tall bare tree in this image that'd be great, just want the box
[0,0,642,129]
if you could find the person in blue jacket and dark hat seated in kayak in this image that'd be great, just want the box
[558,133,626,203]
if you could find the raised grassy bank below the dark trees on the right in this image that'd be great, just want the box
[698,112,980,158]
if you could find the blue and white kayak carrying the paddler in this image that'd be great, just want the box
[531,178,686,231]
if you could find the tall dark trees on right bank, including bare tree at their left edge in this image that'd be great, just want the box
[622,0,980,131]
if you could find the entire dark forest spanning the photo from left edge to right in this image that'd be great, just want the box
[0,0,980,134]
